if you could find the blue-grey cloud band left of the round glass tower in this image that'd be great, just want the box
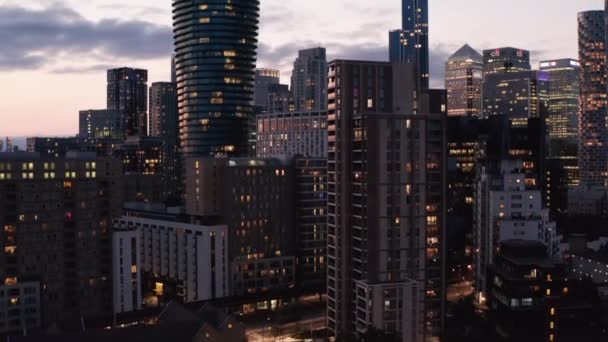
[0,5,173,71]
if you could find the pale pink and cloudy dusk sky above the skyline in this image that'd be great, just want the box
[0,0,604,136]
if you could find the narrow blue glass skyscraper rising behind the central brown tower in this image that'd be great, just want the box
[389,0,430,89]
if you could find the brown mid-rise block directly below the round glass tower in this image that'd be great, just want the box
[185,158,296,298]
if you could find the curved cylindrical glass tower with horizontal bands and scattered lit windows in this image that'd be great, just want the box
[173,0,260,158]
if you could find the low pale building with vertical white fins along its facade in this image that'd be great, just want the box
[114,212,230,311]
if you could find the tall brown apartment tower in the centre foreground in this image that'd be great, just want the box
[327,60,446,341]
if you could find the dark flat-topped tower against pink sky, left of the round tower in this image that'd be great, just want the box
[107,68,148,137]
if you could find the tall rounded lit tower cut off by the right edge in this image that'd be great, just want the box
[578,11,608,186]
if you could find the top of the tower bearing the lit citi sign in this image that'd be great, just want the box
[483,47,532,75]
